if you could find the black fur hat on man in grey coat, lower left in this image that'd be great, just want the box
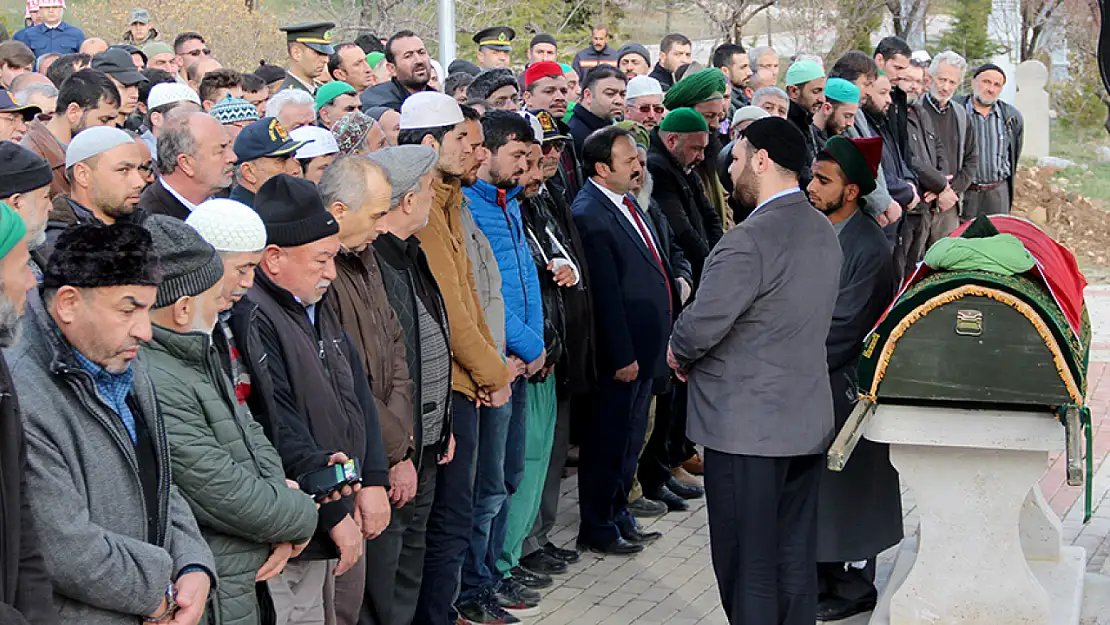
[42,223,162,289]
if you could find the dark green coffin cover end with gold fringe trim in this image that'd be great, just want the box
[859,271,1090,409]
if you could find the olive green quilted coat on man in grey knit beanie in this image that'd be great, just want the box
[145,325,316,625]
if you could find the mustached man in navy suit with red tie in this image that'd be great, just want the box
[572,127,679,555]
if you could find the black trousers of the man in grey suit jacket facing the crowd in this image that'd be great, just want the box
[705,447,825,625]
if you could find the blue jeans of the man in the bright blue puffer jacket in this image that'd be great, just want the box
[460,377,528,601]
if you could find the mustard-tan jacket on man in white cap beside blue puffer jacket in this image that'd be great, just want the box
[416,180,512,399]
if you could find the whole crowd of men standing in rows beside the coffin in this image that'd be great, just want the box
[0,0,1022,625]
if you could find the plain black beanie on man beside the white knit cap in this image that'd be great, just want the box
[254,173,340,248]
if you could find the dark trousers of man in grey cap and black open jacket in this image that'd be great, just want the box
[359,445,437,625]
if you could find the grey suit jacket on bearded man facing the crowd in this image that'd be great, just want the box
[670,192,841,456]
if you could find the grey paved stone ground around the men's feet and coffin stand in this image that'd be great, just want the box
[523,286,1110,625]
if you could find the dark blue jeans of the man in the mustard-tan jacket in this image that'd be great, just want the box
[413,391,478,625]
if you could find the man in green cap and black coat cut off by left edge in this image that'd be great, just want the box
[0,203,59,625]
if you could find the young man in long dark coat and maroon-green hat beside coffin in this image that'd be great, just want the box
[807,137,902,621]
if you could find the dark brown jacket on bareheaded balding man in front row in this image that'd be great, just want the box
[326,248,413,466]
